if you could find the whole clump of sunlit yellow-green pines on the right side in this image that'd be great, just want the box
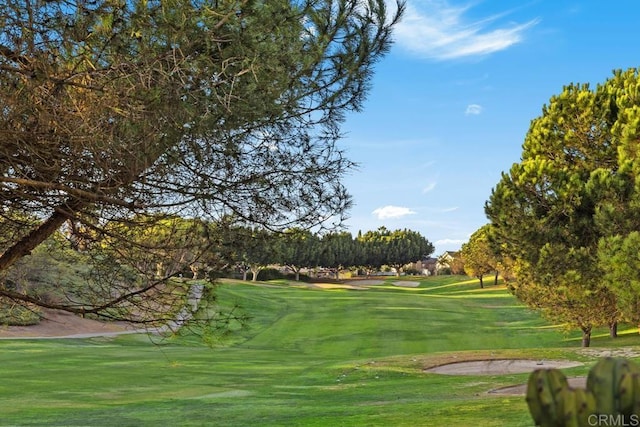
[485,69,640,346]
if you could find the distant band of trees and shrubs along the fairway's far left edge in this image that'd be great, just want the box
[4,221,433,313]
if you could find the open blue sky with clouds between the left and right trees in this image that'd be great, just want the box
[341,0,640,255]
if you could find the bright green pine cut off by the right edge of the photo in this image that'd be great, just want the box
[587,69,640,334]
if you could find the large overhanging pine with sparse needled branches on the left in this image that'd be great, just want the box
[0,0,403,324]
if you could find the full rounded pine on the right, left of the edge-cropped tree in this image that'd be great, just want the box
[485,77,617,346]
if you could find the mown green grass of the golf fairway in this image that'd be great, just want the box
[0,276,638,427]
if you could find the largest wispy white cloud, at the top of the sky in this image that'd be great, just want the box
[394,0,539,60]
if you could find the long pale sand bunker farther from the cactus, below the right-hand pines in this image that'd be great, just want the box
[424,359,582,375]
